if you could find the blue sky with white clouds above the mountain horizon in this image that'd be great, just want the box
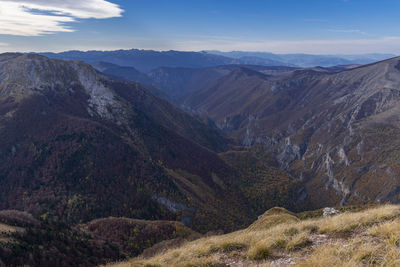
[0,0,400,55]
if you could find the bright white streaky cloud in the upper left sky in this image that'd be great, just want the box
[0,0,123,36]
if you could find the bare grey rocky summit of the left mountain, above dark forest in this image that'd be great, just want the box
[0,54,122,119]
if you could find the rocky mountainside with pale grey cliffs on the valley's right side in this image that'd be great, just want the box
[185,58,400,206]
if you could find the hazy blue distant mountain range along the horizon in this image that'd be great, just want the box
[41,49,395,73]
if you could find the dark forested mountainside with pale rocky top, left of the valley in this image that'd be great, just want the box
[0,54,301,236]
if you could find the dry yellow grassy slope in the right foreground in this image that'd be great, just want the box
[106,205,400,267]
